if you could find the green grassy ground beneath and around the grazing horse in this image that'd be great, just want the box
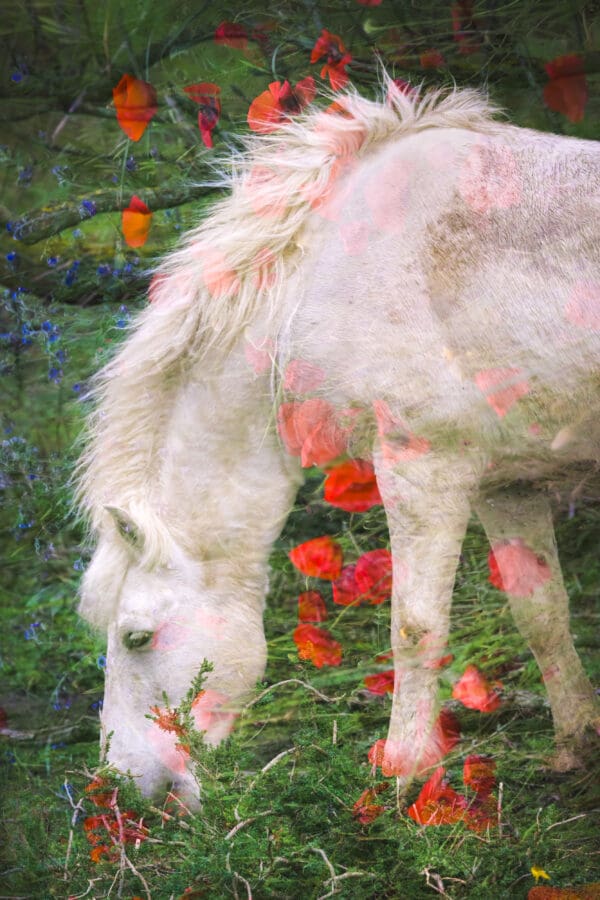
[0,294,600,900]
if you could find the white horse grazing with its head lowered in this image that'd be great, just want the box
[79,80,600,803]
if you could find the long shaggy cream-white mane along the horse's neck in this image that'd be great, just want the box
[75,75,502,565]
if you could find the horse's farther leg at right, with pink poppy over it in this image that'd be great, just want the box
[475,490,600,770]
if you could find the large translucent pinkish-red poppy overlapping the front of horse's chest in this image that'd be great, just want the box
[277,397,351,468]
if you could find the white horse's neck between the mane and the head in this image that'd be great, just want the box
[155,348,299,562]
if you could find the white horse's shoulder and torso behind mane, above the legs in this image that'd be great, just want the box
[281,126,600,474]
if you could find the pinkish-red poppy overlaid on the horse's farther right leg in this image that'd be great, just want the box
[488,538,552,597]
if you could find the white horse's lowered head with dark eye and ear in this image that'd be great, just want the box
[80,509,266,806]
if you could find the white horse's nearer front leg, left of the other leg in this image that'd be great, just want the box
[376,448,481,783]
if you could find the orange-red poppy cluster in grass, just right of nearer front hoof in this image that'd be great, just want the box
[408,755,497,831]
